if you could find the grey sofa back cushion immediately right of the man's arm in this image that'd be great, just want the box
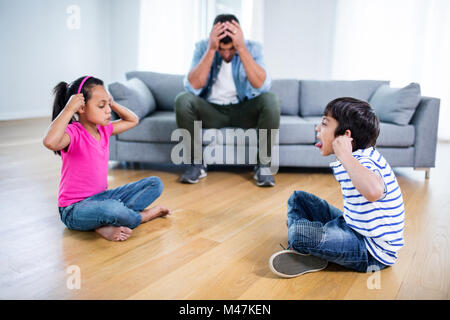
[270,79,300,116]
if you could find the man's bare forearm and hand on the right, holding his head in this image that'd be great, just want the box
[225,20,267,88]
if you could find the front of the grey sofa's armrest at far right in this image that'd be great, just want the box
[411,97,440,168]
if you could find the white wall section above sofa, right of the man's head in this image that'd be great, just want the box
[264,0,336,80]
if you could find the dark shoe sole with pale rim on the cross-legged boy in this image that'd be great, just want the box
[269,250,328,278]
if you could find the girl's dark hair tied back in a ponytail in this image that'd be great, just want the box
[52,76,103,155]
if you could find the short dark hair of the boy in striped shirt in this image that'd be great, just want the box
[323,97,380,151]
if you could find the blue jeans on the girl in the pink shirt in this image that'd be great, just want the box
[59,177,163,231]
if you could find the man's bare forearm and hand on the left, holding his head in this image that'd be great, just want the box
[188,22,226,90]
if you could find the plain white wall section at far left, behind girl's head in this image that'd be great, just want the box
[0,0,111,120]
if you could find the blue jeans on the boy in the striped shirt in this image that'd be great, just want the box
[287,191,386,272]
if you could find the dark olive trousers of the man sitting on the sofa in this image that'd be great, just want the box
[174,92,280,163]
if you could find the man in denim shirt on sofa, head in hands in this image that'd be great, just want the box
[175,14,280,186]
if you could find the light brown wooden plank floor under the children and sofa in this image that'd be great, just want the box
[0,119,450,299]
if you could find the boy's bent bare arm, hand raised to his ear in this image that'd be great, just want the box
[333,135,385,202]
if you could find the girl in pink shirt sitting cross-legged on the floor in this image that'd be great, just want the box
[44,76,170,241]
